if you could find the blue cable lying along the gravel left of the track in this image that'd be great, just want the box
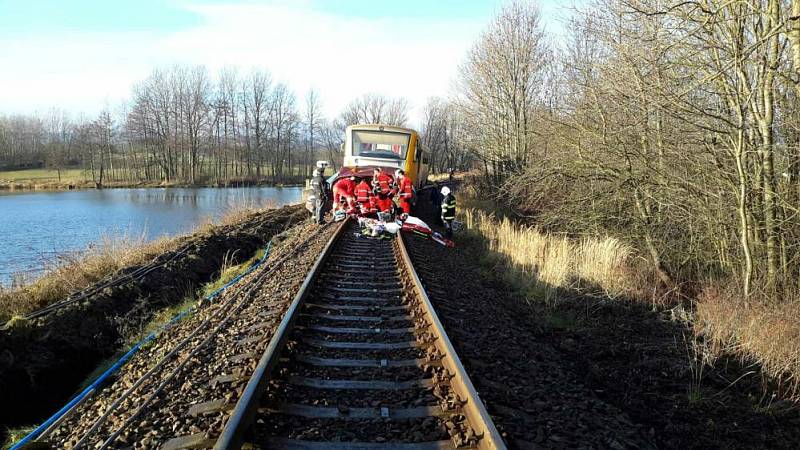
[9,243,272,450]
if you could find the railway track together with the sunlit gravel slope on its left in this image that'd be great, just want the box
[28,221,505,450]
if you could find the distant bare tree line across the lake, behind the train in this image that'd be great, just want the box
[0,66,418,186]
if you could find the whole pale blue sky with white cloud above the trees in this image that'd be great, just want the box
[0,0,563,121]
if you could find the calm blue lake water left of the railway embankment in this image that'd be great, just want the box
[0,187,303,286]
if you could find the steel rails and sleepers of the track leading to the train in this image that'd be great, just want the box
[215,223,505,450]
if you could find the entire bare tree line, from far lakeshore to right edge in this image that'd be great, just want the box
[10,0,800,298]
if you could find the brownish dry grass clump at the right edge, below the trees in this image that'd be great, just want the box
[694,287,800,400]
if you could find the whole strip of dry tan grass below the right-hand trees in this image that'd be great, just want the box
[459,198,800,401]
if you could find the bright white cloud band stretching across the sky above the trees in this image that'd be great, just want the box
[0,2,488,127]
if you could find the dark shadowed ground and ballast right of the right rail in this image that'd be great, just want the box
[408,192,800,449]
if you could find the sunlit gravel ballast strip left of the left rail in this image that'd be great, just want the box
[45,222,335,448]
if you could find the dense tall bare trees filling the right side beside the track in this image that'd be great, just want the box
[418,0,800,299]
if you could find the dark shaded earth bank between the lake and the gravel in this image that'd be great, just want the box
[0,206,307,436]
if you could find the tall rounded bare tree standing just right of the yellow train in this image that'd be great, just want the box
[458,2,550,175]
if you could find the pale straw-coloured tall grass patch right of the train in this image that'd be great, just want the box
[462,209,636,300]
